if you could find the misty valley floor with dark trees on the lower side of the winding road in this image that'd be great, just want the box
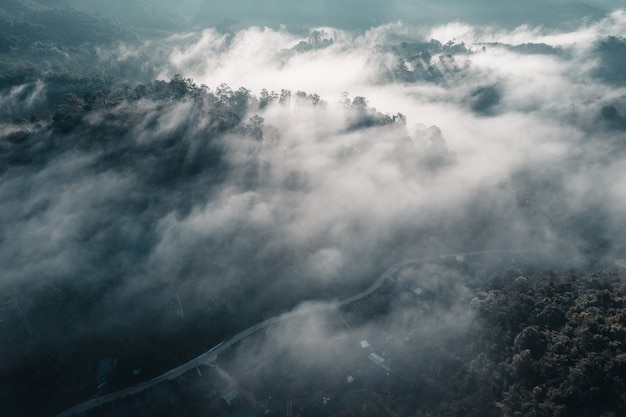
[52,254,626,417]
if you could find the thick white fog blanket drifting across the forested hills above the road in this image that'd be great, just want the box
[0,12,626,380]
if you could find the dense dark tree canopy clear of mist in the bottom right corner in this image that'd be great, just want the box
[477,271,626,416]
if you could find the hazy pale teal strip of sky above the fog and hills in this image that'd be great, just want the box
[35,0,623,30]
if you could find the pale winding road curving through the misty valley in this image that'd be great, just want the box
[56,250,533,417]
